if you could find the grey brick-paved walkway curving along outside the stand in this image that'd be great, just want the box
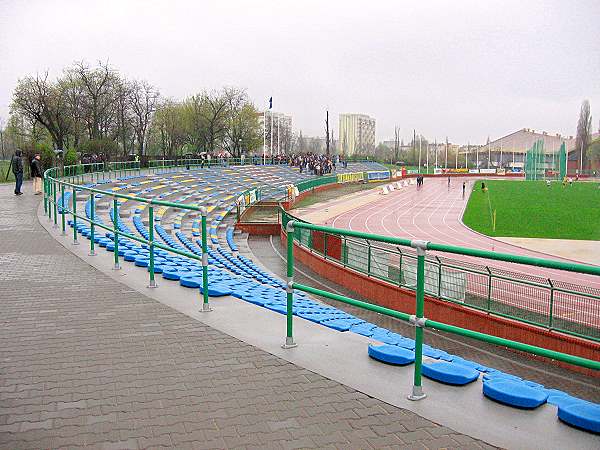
[0,181,489,449]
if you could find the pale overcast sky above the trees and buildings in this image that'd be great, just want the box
[0,0,600,143]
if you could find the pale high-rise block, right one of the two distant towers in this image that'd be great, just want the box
[338,114,375,156]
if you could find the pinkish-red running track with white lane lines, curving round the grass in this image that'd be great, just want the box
[324,177,600,326]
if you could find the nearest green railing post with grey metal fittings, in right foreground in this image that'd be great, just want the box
[408,240,429,400]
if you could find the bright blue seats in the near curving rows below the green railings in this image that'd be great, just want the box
[57,166,600,432]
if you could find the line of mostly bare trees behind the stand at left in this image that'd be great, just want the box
[0,62,262,162]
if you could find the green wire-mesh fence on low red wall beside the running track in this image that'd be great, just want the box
[280,209,600,341]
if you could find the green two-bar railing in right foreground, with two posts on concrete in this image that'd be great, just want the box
[282,219,600,400]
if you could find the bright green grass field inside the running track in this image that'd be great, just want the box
[463,180,600,240]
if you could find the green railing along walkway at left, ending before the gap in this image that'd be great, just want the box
[44,163,210,311]
